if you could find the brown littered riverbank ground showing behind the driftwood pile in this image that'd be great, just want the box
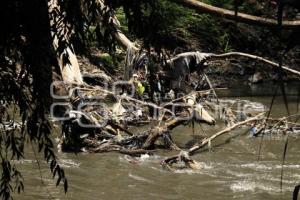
[78,49,300,88]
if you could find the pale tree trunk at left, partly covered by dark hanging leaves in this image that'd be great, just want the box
[48,0,83,84]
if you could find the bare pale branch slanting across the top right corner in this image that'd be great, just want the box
[175,0,300,28]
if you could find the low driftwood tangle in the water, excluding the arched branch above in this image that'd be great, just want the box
[53,70,300,170]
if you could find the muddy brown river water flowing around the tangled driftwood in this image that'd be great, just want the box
[15,83,300,200]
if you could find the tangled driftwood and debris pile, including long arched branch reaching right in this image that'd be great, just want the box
[50,51,300,169]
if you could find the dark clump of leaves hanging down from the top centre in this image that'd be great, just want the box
[107,0,183,50]
